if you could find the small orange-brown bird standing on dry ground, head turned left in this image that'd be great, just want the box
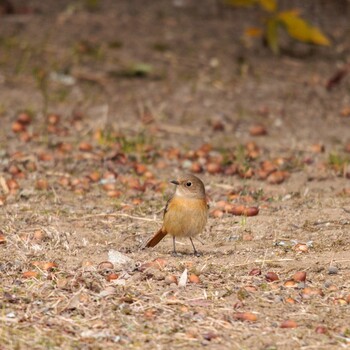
[145,174,208,256]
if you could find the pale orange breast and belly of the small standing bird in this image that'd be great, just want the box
[163,197,208,237]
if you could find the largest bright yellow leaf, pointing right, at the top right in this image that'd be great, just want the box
[278,10,330,46]
